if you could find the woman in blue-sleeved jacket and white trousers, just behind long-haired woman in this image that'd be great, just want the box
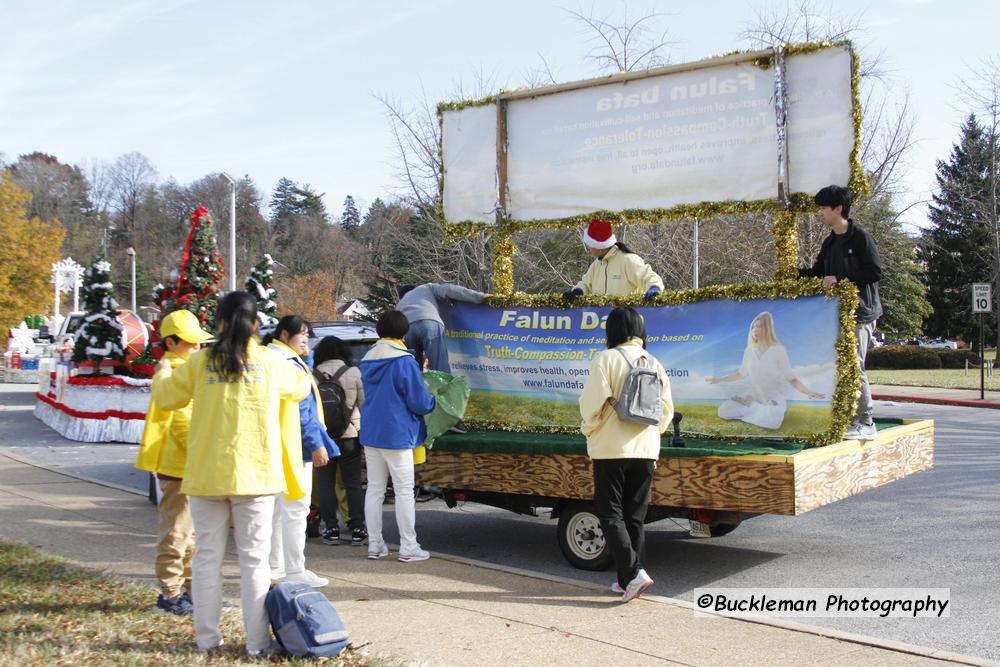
[265,315,340,588]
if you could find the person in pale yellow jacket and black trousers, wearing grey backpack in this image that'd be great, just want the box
[580,308,674,602]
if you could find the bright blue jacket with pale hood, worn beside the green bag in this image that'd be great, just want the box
[360,338,434,449]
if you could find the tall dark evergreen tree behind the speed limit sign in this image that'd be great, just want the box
[922,115,995,342]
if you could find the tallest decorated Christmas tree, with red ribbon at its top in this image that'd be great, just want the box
[171,206,225,331]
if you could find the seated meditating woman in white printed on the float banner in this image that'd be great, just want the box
[705,311,823,429]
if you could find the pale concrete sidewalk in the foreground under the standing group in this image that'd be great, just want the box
[0,454,992,666]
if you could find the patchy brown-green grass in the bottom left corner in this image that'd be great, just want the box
[0,541,372,667]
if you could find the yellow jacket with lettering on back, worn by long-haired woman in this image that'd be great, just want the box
[152,340,309,500]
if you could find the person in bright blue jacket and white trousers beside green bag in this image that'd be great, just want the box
[360,310,434,563]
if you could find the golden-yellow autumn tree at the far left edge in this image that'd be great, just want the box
[0,174,65,344]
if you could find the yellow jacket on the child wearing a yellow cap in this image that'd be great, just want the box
[135,352,191,478]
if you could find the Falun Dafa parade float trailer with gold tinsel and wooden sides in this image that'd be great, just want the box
[418,42,934,569]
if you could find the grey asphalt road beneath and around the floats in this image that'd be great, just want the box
[0,385,1000,660]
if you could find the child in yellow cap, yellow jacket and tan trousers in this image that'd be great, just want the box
[135,310,212,616]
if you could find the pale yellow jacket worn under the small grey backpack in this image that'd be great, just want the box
[580,338,674,459]
